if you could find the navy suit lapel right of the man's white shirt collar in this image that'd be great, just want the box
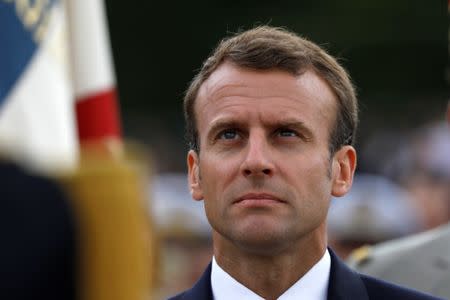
[327,248,369,300]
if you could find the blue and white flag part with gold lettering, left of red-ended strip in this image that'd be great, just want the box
[0,0,78,171]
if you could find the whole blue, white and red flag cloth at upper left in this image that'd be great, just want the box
[0,0,121,173]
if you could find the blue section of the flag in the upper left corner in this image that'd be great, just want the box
[0,0,55,105]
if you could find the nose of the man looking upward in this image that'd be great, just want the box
[241,133,274,177]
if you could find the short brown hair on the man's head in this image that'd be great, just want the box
[184,26,358,153]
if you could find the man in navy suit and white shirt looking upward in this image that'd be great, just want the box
[168,26,440,300]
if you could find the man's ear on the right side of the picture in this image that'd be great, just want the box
[331,146,356,197]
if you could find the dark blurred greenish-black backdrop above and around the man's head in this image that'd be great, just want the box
[106,0,449,171]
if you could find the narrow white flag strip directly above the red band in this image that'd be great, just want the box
[67,0,115,98]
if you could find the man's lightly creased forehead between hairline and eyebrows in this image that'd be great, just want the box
[194,62,337,131]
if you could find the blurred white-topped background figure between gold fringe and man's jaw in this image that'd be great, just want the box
[150,173,212,299]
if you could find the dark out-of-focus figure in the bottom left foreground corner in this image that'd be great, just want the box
[0,160,76,300]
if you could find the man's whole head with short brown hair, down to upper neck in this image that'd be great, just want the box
[185,27,356,254]
